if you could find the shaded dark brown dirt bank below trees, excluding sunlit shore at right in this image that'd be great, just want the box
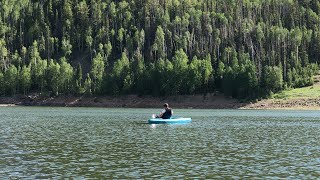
[0,95,245,109]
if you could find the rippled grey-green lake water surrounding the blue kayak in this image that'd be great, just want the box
[0,107,320,179]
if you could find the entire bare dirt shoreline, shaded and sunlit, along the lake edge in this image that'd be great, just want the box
[0,94,320,110]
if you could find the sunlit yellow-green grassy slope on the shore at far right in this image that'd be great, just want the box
[272,83,320,100]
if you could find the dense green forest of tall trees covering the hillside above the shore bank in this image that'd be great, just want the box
[0,0,320,98]
